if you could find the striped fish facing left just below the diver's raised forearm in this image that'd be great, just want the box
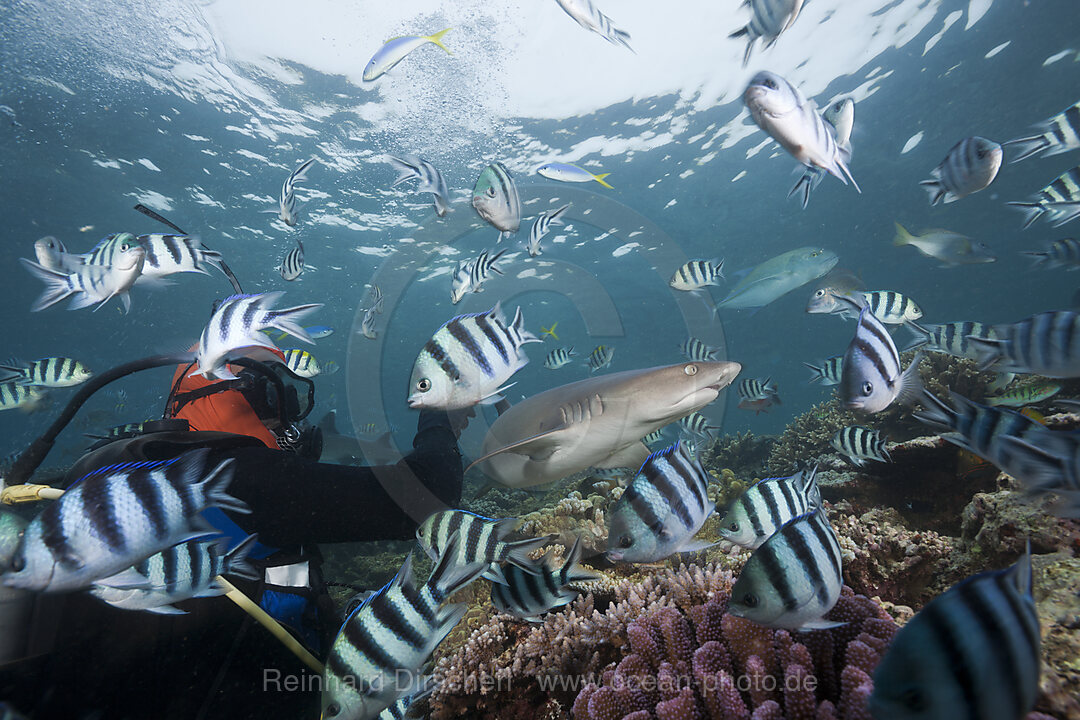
[416,510,553,579]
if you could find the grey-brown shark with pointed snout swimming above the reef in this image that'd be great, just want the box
[470,363,742,488]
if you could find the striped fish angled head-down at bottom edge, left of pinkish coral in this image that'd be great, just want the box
[322,535,484,720]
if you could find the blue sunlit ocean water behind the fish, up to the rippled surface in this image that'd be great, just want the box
[0,0,1080,455]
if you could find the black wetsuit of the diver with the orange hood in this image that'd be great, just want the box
[0,412,462,720]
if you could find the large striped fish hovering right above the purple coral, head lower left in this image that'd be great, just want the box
[728,506,843,630]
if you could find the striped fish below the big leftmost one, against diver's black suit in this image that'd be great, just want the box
[90,535,259,615]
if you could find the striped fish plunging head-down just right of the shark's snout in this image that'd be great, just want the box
[840,307,922,413]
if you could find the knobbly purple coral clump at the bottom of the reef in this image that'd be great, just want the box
[572,588,897,720]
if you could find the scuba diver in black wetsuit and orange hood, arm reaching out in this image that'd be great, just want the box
[0,351,473,720]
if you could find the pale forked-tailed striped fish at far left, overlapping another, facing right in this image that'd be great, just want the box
[19,237,146,313]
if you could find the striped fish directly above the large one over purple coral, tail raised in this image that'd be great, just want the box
[719,466,821,549]
